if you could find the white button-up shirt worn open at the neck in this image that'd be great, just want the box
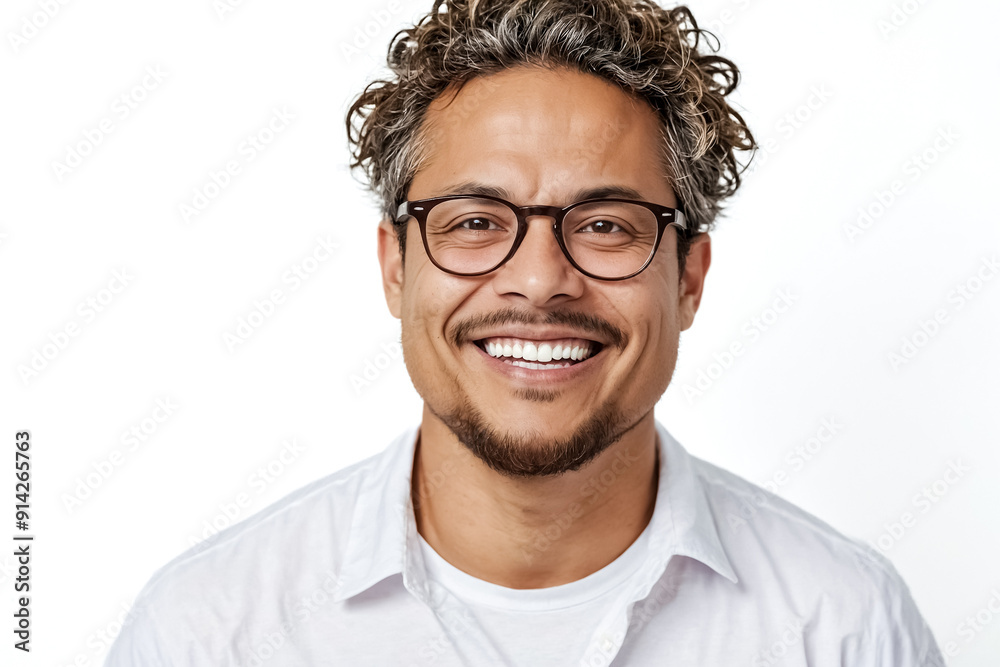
[105,422,944,667]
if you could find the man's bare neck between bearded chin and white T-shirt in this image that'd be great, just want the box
[411,406,658,588]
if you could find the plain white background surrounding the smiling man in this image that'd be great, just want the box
[0,0,1000,667]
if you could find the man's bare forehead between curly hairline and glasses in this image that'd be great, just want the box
[408,66,675,205]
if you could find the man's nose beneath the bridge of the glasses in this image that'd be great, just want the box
[493,215,585,306]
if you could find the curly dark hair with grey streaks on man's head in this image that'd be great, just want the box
[347,0,757,273]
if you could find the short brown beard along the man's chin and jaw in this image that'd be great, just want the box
[428,392,642,478]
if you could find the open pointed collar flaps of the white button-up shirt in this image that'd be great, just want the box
[334,421,739,602]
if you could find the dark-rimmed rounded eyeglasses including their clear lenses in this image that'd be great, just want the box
[393,195,692,280]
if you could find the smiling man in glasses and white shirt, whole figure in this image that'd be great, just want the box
[108,0,943,667]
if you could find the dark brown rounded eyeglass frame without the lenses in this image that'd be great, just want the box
[392,195,694,281]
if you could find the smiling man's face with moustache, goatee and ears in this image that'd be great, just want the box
[379,68,710,476]
